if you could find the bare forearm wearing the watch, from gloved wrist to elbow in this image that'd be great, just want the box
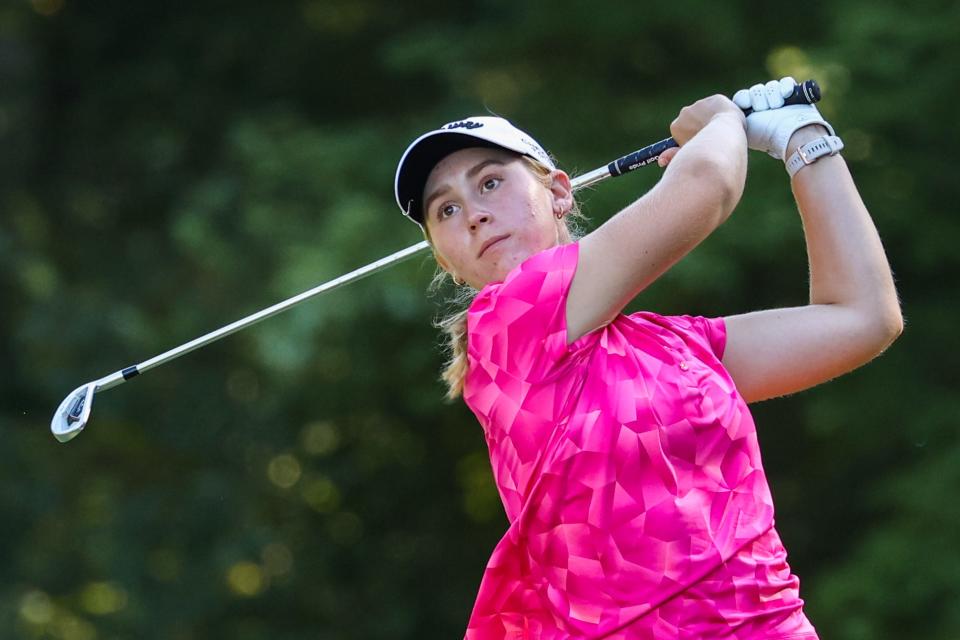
[787,127,902,339]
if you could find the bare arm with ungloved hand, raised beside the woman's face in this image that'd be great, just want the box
[566,96,747,343]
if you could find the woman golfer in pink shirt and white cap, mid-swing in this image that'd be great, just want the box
[396,78,902,640]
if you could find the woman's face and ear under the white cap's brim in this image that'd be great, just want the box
[423,147,573,289]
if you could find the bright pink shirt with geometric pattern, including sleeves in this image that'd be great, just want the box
[464,243,817,640]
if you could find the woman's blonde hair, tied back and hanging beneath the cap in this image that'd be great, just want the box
[423,156,583,400]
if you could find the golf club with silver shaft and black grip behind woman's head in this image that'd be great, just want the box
[50,80,820,442]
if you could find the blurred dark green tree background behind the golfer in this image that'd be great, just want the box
[0,0,960,640]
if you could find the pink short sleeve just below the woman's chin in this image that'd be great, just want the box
[467,243,579,382]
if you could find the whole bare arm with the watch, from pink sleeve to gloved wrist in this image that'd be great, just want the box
[723,125,903,402]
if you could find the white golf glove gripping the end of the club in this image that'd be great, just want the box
[733,77,834,161]
